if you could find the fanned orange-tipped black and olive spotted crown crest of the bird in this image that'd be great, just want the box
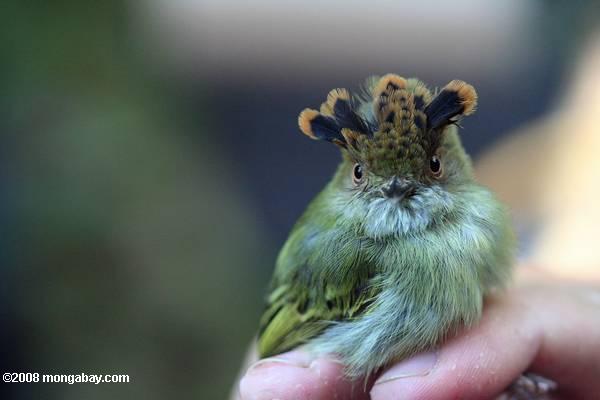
[298,74,477,174]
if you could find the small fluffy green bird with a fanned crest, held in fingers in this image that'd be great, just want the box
[258,74,515,378]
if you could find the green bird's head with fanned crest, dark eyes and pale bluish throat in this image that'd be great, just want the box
[298,74,477,237]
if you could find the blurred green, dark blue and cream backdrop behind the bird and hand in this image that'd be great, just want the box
[0,0,600,399]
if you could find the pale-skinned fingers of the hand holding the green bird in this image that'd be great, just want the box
[232,266,600,400]
